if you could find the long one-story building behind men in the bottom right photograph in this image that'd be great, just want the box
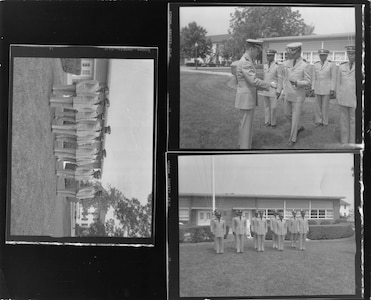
[179,193,345,226]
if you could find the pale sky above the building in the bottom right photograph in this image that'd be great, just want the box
[178,153,354,208]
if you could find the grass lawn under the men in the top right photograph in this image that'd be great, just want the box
[179,72,343,149]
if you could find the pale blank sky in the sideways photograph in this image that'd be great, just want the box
[102,59,154,204]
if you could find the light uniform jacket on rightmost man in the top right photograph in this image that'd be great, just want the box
[336,62,357,107]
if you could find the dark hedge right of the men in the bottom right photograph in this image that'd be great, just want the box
[308,224,354,240]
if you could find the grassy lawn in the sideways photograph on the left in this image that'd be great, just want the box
[10,58,70,236]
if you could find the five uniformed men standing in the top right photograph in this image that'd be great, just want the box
[235,39,357,149]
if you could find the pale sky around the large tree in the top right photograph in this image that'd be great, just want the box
[179,6,355,35]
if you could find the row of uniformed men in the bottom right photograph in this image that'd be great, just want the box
[210,210,309,254]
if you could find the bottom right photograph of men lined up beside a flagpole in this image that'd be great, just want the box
[174,153,362,298]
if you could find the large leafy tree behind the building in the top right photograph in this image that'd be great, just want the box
[229,6,314,57]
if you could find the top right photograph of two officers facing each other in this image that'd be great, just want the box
[175,5,364,150]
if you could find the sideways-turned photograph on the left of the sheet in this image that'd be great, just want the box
[7,45,157,242]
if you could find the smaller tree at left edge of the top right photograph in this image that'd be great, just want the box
[180,22,212,58]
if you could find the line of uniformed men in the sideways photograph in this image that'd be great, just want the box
[50,80,111,202]
